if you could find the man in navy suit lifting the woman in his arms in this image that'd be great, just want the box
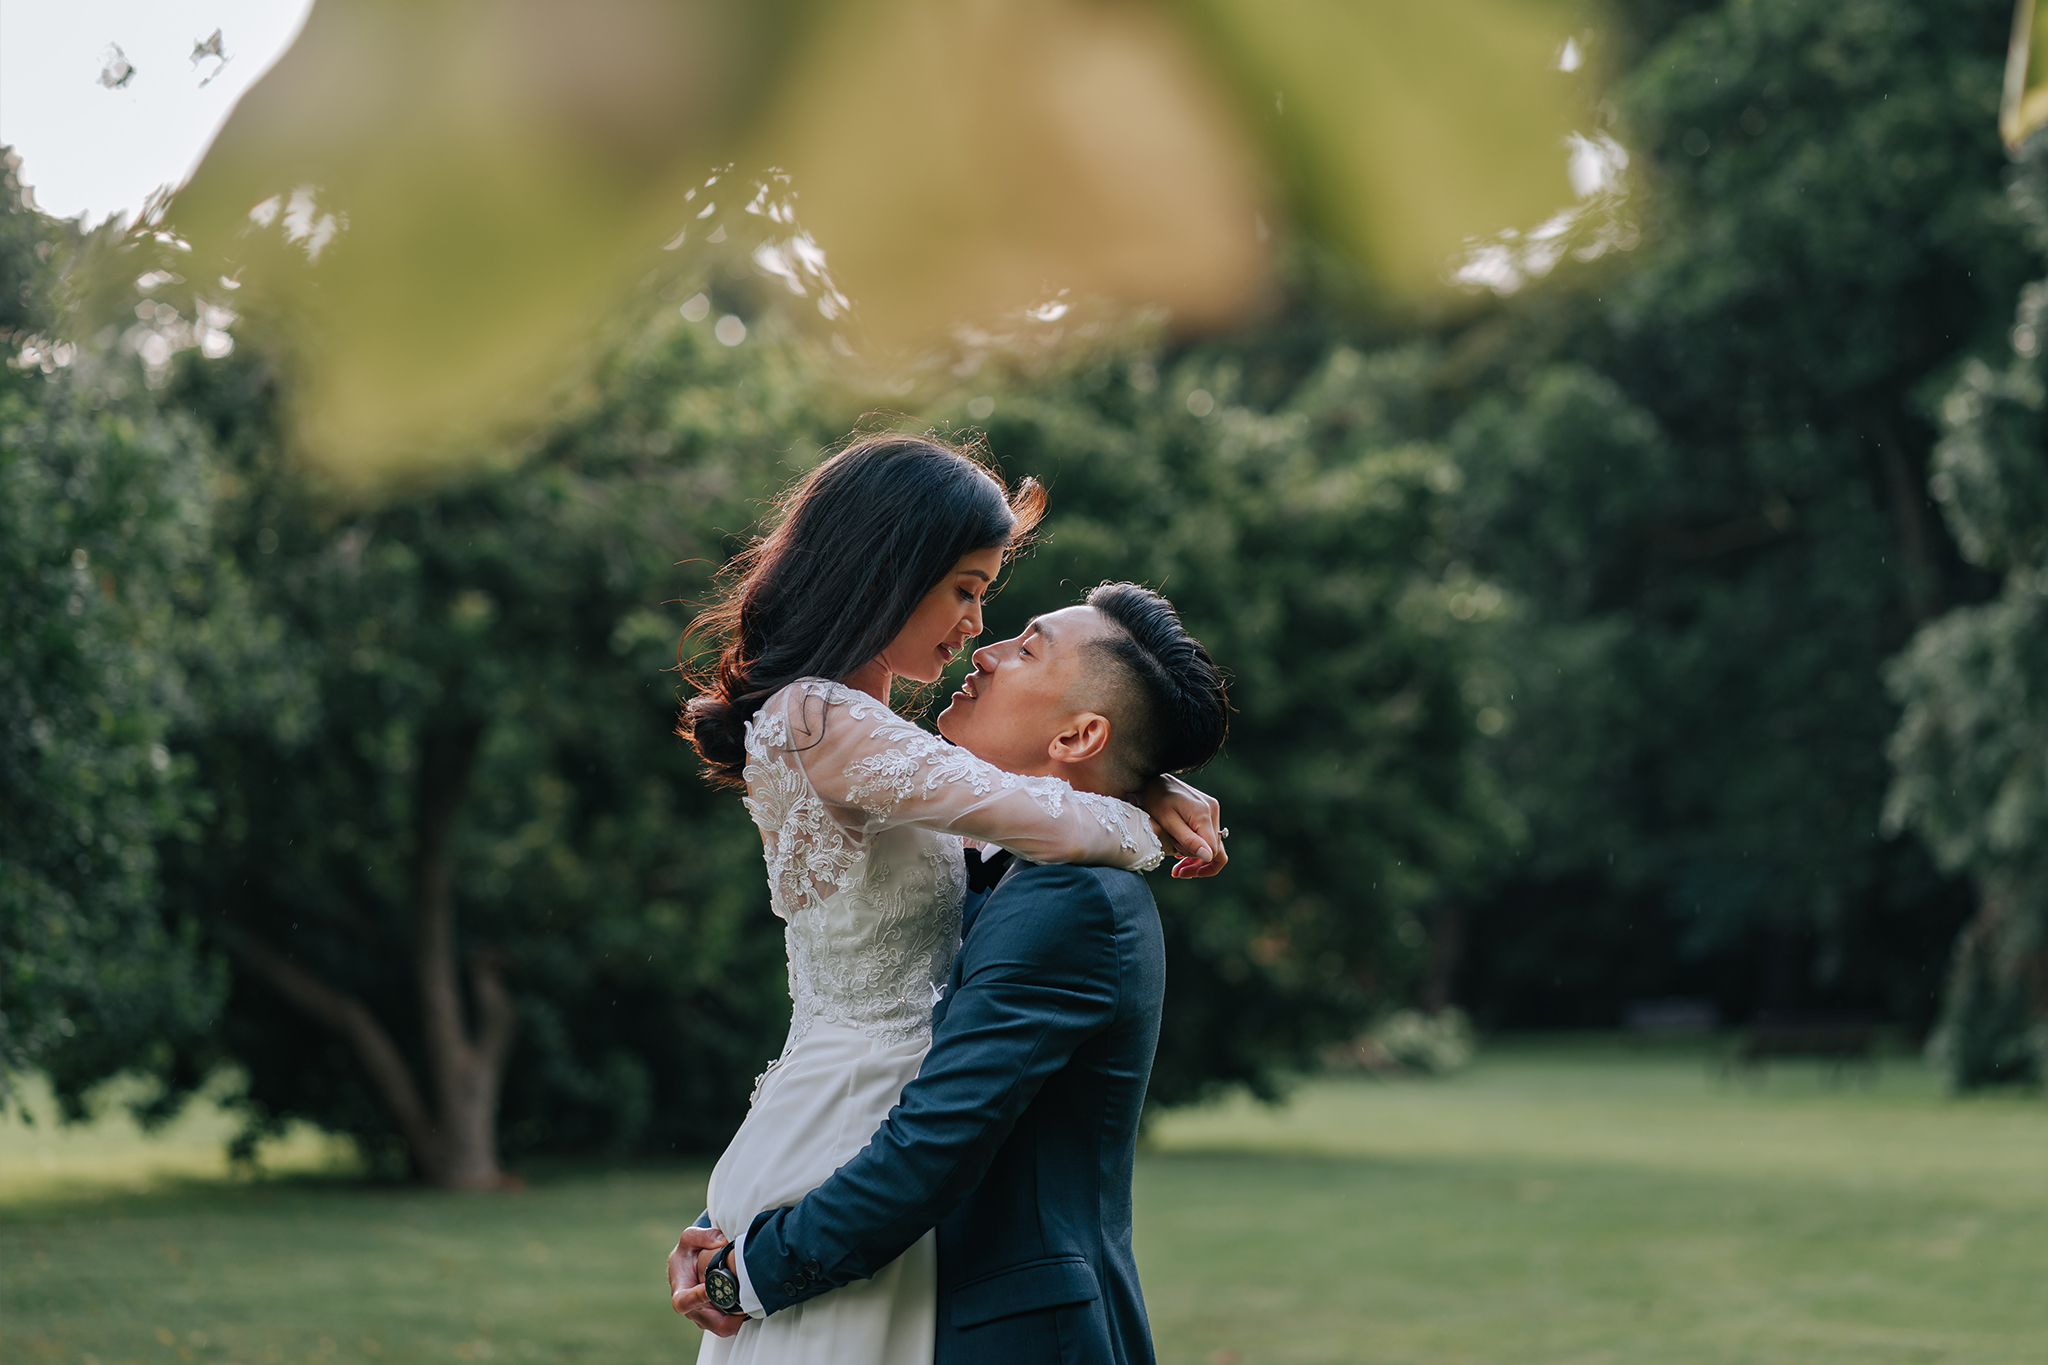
[670,583,1227,1365]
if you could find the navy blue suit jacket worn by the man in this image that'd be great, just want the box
[745,864,1165,1365]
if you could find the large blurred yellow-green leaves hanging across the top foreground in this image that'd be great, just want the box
[125,0,1587,485]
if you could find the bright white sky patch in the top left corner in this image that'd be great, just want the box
[0,0,313,223]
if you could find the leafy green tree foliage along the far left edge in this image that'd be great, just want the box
[0,158,225,1115]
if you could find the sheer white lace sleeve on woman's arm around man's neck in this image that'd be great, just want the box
[764,681,1165,870]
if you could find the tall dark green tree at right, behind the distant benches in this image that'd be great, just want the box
[1438,0,2023,1023]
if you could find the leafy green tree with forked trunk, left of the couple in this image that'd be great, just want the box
[149,321,839,1187]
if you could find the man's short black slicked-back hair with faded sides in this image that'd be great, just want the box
[1085,583,1231,790]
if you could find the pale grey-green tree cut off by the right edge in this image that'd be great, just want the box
[1884,137,2048,1087]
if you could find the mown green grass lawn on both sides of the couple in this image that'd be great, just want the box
[0,1042,2048,1365]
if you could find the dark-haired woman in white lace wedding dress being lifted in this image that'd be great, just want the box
[680,436,1221,1365]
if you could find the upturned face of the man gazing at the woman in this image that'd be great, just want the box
[938,606,1114,776]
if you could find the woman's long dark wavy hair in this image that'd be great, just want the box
[676,436,1044,786]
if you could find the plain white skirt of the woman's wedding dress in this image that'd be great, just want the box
[696,1019,938,1365]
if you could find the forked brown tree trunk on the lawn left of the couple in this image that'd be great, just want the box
[233,724,518,1189]
